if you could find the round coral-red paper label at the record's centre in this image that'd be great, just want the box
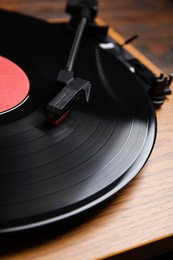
[0,56,30,114]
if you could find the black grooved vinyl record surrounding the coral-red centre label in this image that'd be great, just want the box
[0,11,156,233]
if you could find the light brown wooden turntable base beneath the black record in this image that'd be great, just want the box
[1,2,173,260]
